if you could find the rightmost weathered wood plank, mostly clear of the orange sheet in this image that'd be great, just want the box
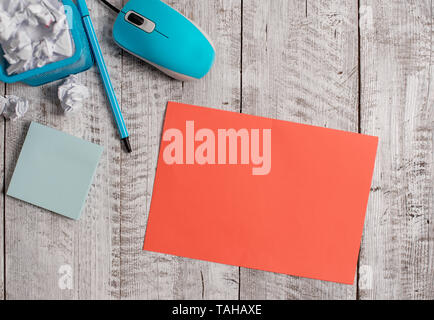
[360,0,434,299]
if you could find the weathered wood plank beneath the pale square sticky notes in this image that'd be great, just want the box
[6,1,122,299]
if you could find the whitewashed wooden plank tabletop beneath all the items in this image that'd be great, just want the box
[0,0,434,299]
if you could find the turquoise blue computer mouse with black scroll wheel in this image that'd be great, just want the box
[113,0,215,81]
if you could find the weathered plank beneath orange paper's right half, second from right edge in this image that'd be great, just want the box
[240,0,358,299]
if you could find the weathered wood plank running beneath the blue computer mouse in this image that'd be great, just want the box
[121,0,241,299]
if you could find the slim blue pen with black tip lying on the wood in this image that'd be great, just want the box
[77,0,133,153]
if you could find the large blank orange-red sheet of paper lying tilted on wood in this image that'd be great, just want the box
[144,102,378,284]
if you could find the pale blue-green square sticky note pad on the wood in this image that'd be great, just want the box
[7,122,103,219]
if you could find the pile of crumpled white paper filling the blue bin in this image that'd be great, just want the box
[0,0,74,75]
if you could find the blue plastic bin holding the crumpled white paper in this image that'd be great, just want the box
[0,0,95,86]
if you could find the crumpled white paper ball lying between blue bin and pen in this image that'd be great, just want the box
[58,75,89,113]
